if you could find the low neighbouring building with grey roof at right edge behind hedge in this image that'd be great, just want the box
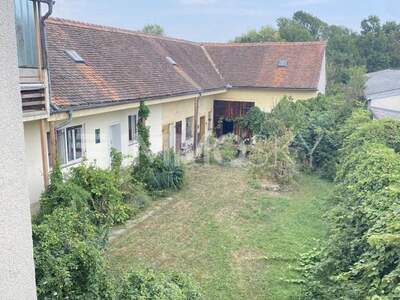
[364,70,400,119]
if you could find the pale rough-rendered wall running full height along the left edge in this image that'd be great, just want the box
[0,0,40,299]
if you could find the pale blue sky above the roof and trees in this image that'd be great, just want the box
[54,0,400,42]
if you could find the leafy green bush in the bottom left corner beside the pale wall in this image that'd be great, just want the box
[32,207,114,299]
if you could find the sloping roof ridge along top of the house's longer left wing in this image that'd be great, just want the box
[46,17,201,46]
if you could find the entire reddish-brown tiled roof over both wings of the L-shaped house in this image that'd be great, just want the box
[46,19,324,109]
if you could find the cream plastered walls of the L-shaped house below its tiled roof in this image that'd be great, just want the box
[24,88,318,204]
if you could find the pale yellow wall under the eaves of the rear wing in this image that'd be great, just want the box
[214,88,318,112]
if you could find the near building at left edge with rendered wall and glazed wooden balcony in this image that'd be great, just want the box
[0,0,53,299]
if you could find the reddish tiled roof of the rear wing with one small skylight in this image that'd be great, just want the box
[205,42,325,90]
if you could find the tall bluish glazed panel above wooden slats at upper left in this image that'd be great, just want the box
[15,0,38,68]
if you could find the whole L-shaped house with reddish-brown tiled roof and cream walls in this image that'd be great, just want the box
[25,19,325,203]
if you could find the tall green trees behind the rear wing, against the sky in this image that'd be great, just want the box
[235,11,400,87]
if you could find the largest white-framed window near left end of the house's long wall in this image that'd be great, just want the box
[57,125,83,164]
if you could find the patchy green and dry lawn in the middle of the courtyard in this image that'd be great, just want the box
[109,166,332,300]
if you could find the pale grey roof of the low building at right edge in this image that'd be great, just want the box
[364,69,400,100]
